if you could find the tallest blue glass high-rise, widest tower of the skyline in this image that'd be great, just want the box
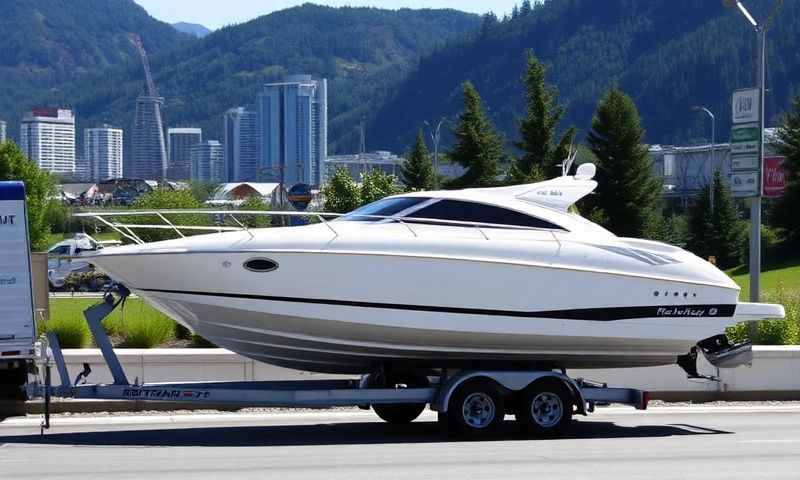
[258,75,328,186]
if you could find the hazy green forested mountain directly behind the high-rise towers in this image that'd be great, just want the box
[29,4,480,156]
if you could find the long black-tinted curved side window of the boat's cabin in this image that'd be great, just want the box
[408,199,564,230]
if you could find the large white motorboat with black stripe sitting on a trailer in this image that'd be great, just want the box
[79,164,784,374]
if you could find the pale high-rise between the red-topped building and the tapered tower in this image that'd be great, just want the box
[83,125,122,182]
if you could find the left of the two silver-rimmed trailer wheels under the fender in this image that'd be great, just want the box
[447,379,505,438]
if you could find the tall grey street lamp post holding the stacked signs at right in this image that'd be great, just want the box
[723,0,783,304]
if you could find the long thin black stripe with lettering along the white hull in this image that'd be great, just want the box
[137,288,736,322]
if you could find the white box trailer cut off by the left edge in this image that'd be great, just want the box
[0,182,36,406]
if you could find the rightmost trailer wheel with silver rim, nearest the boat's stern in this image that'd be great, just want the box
[515,380,574,435]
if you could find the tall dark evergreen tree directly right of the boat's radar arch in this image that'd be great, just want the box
[586,87,661,237]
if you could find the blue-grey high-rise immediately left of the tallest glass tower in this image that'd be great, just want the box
[223,107,259,182]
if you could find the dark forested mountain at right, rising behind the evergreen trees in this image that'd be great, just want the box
[368,0,800,149]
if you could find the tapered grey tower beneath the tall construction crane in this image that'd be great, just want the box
[130,95,167,180]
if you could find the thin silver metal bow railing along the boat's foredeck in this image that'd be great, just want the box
[73,209,561,245]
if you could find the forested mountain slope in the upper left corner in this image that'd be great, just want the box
[0,0,191,139]
